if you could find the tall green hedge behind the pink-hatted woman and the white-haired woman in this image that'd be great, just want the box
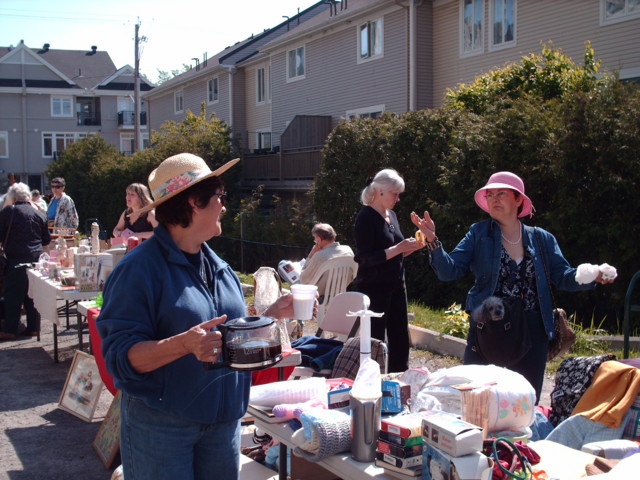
[314,44,640,325]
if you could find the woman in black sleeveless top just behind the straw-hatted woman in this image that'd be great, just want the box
[111,183,158,245]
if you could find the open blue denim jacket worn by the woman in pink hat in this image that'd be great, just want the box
[429,219,595,339]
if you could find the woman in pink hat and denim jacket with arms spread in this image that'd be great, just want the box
[411,172,613,401]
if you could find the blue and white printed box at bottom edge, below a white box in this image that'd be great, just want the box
[422,445,493,480]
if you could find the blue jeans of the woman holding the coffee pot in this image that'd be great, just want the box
[120,392,240,480]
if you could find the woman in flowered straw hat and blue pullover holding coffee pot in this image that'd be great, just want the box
[97,153,302,480]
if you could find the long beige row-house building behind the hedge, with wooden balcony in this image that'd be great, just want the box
[145,0,640,191]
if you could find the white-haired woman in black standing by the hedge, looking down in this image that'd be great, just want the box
[354,168,423,372]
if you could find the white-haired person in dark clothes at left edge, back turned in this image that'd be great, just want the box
[0,183,51,340]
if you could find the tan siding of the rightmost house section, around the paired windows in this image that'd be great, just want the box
[433,0,640,106]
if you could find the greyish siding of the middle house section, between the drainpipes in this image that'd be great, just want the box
[272,7,408,143]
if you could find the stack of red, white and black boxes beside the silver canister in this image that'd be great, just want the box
[375,414,423,479]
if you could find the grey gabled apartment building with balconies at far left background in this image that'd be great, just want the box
[0,42,154,191]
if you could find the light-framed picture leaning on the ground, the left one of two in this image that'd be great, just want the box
[58,350,102,422]
